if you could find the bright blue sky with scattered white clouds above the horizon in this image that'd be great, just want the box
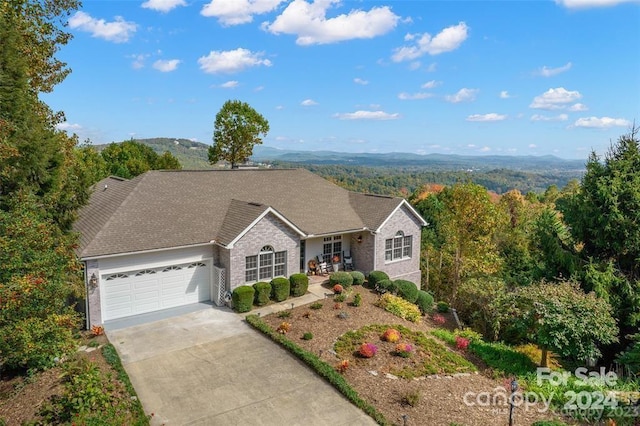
[43,0,640,158]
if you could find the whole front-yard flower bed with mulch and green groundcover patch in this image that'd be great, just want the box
[255,288,552,425]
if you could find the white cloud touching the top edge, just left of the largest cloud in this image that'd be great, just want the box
[200,0,284,26]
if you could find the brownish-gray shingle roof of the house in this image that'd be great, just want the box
[74,169,420,258]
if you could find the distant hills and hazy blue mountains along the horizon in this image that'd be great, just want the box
[102,138,585,173]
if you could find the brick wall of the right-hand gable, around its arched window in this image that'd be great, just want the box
[372,205,422,286]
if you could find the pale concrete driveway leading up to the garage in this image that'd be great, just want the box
[107,307,376,426]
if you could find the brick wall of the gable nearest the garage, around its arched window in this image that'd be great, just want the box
[230,213,300,290]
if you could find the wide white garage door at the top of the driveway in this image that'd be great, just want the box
[100,261,211,321]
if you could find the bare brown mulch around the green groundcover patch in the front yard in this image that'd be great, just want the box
[262,286,556,425]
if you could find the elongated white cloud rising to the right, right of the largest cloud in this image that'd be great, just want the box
[391,22,469,62]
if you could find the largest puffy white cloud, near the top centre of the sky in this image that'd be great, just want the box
[262,0,400,46]
